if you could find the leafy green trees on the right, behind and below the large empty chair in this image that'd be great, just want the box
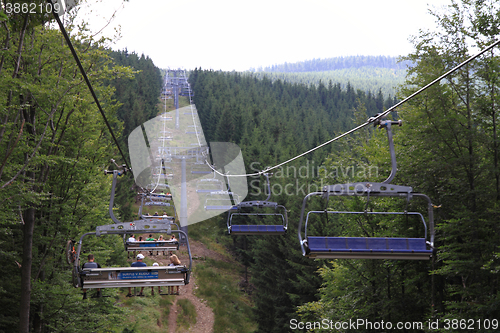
[299,1,500,331]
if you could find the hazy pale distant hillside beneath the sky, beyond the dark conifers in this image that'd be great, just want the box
[250,56,410,98]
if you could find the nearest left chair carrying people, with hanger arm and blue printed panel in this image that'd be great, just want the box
[72,170,192,289]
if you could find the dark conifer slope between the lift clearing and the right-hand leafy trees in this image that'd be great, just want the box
[190,70,396,332]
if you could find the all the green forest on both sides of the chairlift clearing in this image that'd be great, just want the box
[0,0,500,333]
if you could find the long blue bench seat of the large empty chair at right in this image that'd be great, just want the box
[306,236,432,260]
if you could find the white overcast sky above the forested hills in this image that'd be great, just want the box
[75,0,451,71]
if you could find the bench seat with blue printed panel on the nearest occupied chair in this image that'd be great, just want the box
[80,266,189,289]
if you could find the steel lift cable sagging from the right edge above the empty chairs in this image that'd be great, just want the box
[205,40,500,177]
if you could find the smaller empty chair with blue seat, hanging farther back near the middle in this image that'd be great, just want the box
[227,173,288,235]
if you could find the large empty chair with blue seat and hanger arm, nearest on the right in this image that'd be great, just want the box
[298,121,434,260]
